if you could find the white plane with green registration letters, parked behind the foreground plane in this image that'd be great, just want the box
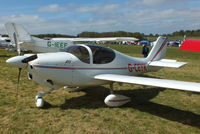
[5,23,138,52]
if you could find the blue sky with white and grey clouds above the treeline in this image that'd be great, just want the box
[0,0,200,35]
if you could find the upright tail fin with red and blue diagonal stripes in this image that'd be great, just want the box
[146,36,167,61]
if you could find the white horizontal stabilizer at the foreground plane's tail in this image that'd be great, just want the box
[149,59,187,68]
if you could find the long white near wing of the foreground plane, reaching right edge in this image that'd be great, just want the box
[94,74,200,92]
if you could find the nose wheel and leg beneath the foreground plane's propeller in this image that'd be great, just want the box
[35,88,55,107]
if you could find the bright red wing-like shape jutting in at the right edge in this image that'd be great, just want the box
[180,39,200,51]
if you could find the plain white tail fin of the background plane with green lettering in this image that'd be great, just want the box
[5,22,31,43]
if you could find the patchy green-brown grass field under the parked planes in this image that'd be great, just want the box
[0,45,200,134]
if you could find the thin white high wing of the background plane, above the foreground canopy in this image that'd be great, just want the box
[52,37,138,42]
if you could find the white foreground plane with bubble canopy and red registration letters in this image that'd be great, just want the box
[6,34,200,107]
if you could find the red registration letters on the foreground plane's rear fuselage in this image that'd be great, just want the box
[128,64,147,72]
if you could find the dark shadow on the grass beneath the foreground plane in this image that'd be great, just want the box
[44,86,200,128]
